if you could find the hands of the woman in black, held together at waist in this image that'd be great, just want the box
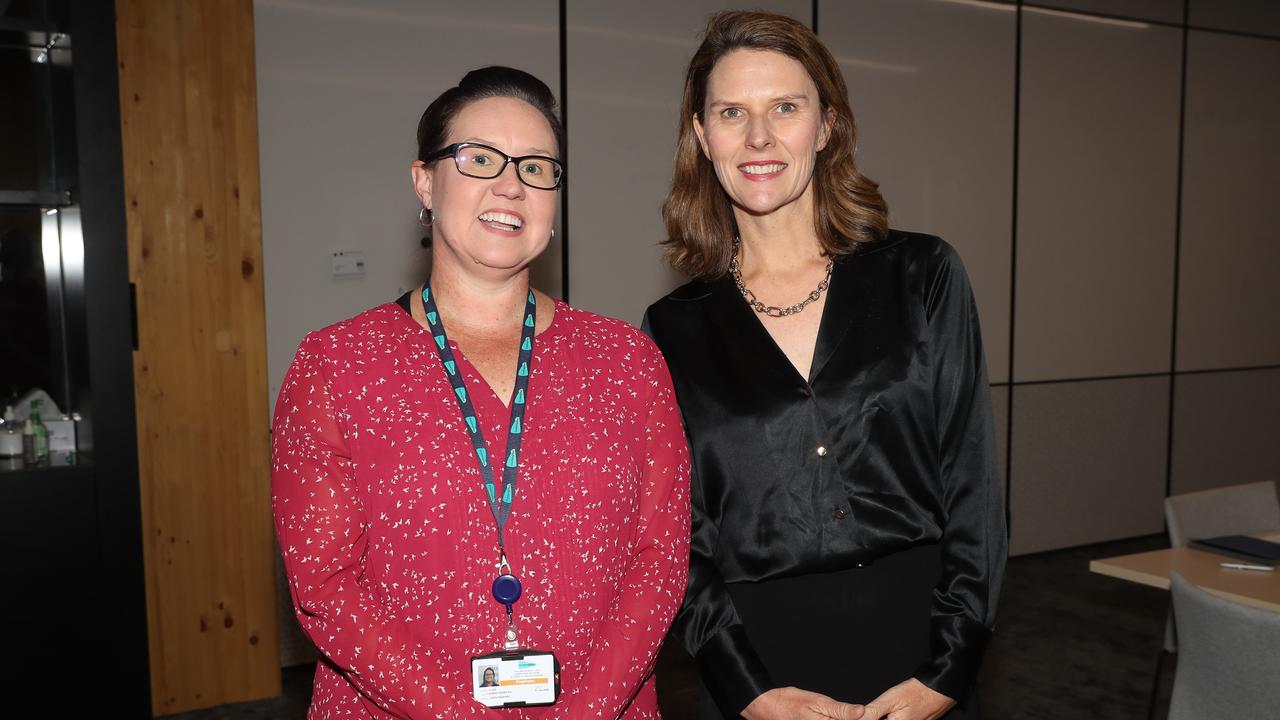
[742,678,956,720]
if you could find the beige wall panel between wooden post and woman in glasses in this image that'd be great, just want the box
[253,0,561,404]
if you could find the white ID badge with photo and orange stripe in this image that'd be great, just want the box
[471,650,559,707]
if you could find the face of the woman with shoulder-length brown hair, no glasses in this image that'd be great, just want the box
[694,50,831,215]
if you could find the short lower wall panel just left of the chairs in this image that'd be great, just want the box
[1010,378,1169,555]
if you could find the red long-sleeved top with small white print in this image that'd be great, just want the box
[271,295,689,720]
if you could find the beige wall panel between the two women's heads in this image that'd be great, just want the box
[567,0,812,324]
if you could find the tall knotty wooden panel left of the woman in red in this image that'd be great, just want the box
[116,0,280,714]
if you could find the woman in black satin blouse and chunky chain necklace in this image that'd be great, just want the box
[645,12,1006,720]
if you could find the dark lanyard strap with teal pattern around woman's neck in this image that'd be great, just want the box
[422,284,538,548]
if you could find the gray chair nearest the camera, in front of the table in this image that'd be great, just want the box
[1169,573,1280,720]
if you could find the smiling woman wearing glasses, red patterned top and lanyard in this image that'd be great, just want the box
[271,68,689,719]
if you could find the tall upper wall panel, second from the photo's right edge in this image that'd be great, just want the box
[1014,8,1181,380]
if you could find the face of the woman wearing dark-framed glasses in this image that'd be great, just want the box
[413,97,558,275]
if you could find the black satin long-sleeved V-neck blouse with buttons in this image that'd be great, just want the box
[645,231,1007,712]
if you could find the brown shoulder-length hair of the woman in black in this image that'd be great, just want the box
[662,10,888,279]
